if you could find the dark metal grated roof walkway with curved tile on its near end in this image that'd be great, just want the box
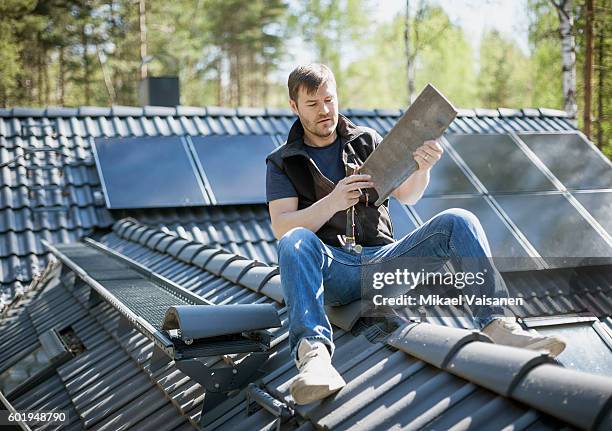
[44,238,281,424]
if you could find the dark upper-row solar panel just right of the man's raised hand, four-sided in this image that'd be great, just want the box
[446,135,557,193]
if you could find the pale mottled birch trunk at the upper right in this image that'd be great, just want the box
[551,0,578,118]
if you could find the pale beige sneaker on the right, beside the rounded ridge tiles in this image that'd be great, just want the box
[482,317,567,358]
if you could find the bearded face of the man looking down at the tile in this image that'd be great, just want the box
[289,82,338,138]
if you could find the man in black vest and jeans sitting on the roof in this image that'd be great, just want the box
[266,64,565,404]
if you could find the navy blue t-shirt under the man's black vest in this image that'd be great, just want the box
[266,135,346,202]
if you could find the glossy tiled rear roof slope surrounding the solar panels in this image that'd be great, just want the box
[0,106,574,296]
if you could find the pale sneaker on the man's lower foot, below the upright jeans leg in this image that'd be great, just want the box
[289,338,346,404]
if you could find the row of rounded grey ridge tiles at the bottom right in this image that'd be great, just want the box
[387,323,612,429]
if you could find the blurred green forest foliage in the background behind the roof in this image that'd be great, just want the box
[0,0,612,155]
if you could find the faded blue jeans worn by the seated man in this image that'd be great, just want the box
[278,208,508,361]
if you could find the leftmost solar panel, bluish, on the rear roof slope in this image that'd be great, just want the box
[94,136,209,208]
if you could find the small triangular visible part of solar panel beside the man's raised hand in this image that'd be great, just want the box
[423,148,478,196]
